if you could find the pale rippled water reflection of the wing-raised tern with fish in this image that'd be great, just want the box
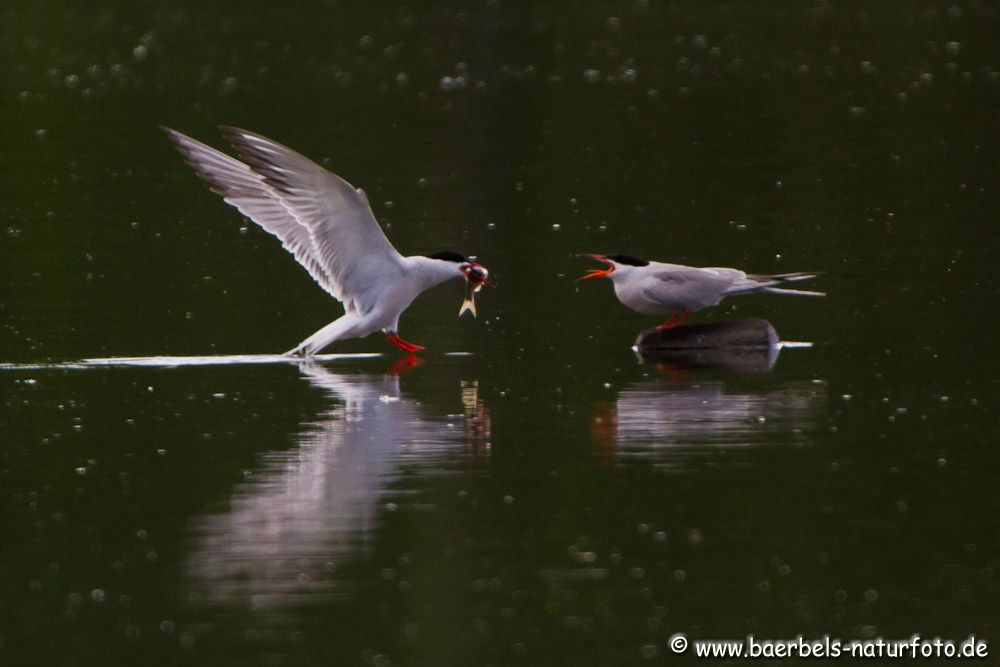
[187,364,490,610]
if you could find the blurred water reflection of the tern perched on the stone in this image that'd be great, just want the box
[590,377,826,467]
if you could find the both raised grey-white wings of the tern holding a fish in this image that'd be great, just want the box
[164,127,403,312]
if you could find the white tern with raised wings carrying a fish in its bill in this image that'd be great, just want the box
[163,126,489,357]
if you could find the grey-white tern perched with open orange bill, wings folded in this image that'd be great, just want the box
[580,254,826,329]
